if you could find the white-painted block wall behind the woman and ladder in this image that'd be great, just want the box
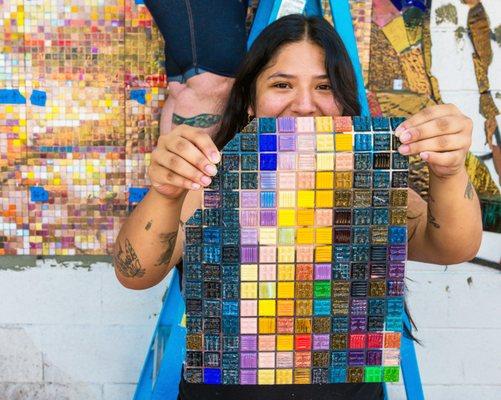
[0,0,501,400]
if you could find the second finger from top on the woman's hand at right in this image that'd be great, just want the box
[399,115,469,144]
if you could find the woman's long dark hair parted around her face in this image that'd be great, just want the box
[215,14,360,149]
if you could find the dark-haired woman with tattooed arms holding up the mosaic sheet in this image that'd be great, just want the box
[114,15,482,400]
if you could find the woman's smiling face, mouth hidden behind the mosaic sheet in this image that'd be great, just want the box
[248,40,343,117]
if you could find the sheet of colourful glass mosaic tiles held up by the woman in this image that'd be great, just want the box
[183,117,408,385]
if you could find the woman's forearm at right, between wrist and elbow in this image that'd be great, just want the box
[425,168,482,264]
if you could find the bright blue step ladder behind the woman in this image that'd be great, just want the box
[134,0,424,400]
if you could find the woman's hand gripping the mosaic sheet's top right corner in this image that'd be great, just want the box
[395,104,473,178]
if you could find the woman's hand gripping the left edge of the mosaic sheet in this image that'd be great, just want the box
[148,125,221,199]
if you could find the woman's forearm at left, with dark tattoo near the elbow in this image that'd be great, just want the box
[113,188,184,289]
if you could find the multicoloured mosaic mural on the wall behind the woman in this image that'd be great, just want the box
[0,0,501,255]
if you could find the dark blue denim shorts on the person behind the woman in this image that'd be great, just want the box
[145,0,248,83]
